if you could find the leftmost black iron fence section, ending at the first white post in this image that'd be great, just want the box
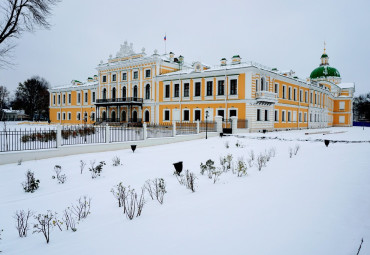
[0,128,57,152]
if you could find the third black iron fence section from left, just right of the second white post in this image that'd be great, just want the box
[110,125,144,142]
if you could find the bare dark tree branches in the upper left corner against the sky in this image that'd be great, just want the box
[0,0,61,68]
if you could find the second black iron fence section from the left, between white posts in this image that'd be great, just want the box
[61,125,106,145]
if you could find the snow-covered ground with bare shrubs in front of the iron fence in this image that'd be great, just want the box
[0,128,370,255]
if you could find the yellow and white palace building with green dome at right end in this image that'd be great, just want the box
[49,42,355,132]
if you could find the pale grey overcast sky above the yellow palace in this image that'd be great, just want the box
[0,0,370,95]
